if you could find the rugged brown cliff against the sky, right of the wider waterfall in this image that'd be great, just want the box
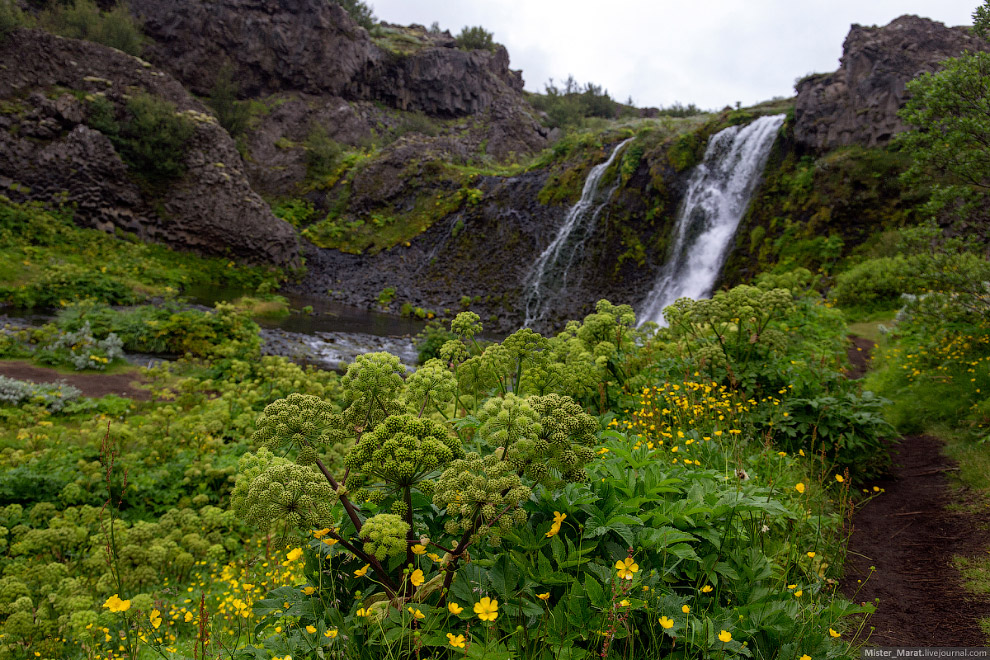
[794,16,987,152]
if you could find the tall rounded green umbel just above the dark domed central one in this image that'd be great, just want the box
[340,353,406,430]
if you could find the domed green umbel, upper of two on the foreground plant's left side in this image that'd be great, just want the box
[253,394,347,452]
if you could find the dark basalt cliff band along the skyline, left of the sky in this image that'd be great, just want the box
[129,0,523,117]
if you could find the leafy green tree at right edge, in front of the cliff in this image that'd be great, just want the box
[897,0,990,222]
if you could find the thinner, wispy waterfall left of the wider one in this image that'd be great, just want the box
[523,138,632,327]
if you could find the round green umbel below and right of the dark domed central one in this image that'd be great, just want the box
[433,452,531,545]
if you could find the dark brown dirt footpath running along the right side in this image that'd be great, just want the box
[842,338,990,647]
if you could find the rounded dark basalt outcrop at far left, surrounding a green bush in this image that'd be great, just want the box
[0,30,298,265]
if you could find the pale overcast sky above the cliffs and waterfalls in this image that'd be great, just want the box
[369,0,980,109]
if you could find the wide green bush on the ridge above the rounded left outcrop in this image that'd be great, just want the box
[41,0,144,55]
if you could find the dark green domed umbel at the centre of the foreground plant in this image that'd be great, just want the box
[345,415,464,490]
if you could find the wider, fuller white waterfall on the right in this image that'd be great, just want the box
[637,115,784,325]
